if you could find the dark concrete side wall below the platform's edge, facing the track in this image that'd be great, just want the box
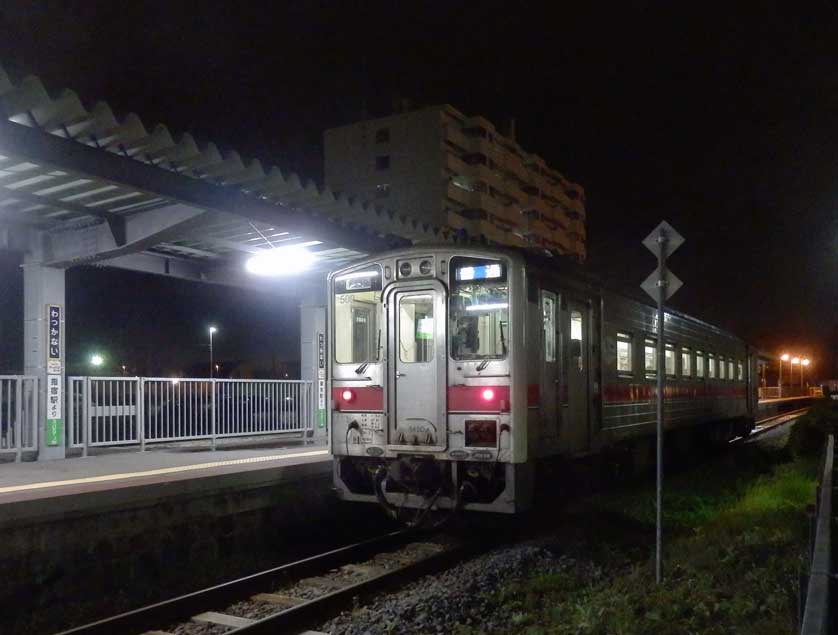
[0,461,345,633]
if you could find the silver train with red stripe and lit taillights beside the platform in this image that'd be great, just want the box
[327,245,757,518]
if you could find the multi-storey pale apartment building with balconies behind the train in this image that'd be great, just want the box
[324,105,585,261]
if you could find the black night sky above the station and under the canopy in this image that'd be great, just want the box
[0,0,838,375]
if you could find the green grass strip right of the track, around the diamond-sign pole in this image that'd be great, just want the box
[458,432,817,635]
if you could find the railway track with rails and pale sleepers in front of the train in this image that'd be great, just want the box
[58,530,488,635]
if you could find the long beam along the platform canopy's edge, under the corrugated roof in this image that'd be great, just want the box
[0,120,410,253]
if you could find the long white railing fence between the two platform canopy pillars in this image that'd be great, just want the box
[67,377,314,453]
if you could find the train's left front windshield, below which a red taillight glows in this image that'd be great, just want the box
[334,266,383,364]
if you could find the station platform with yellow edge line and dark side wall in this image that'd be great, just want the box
[0,444,338,634]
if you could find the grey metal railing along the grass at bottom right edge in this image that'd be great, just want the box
[800,434,835,635]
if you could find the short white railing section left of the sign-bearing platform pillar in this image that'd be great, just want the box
[0,375,38,461]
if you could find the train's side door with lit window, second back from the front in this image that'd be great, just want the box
[562,300,590,452]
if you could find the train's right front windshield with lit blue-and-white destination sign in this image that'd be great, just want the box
[448,257,509,360]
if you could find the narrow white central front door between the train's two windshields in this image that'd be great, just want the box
[387,287,447,451]
